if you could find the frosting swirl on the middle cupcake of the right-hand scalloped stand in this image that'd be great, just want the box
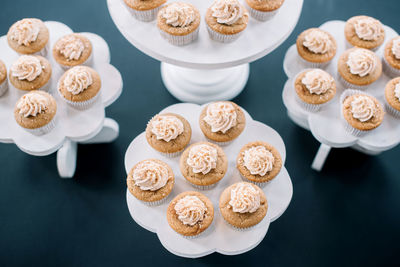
[347,49,377,77]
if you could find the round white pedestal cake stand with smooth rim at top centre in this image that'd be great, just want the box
[107,0,303,104]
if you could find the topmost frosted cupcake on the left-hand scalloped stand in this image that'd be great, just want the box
[7,19,49,57]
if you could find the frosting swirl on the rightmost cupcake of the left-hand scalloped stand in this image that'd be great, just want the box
[64,66,93,95]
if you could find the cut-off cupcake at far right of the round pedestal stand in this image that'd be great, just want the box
[245,0,285,21]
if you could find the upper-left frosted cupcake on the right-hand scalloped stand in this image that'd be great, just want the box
[296,28,337,68]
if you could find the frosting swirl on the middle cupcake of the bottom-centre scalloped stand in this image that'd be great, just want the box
[186,144,218,174]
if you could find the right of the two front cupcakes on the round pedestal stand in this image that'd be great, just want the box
[206,0,249,43]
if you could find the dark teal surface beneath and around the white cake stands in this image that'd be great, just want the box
[0,0,400,266]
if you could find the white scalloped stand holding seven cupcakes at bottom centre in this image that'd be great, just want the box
[125,104,293,258]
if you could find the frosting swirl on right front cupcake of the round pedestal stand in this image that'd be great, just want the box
[211,0,245,25]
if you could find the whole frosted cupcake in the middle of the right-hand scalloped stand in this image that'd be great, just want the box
[338,47,382,90]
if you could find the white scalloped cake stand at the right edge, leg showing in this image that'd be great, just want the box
[282,21,400,171]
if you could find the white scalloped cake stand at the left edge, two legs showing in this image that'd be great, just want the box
[0,21,123,178]
